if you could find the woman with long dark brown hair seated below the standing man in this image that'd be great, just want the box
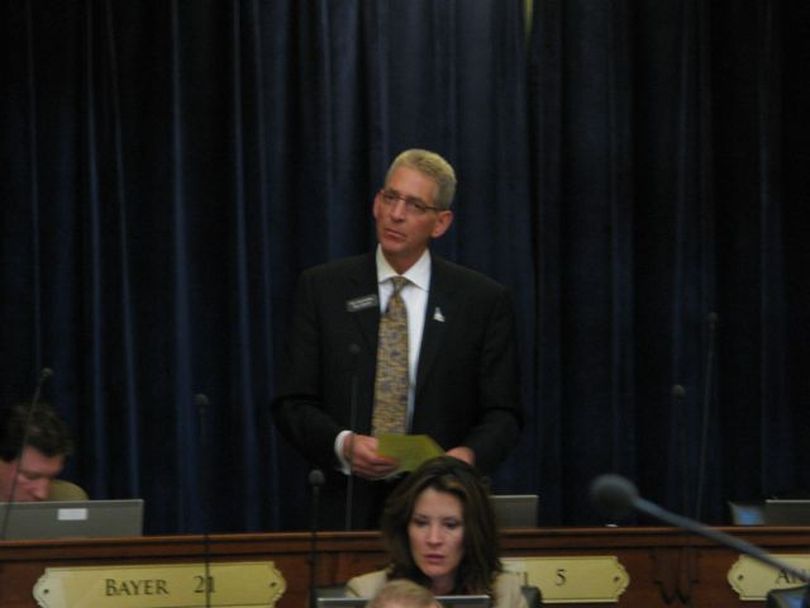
[346,456,527,608]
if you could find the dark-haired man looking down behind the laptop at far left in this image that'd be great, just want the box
[0,403,87,502]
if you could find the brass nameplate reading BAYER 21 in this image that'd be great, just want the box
[34,562,287,608]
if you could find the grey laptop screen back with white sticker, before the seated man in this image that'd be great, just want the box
[0,498,143,540]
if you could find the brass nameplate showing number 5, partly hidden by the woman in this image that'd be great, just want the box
[503,555,630,604]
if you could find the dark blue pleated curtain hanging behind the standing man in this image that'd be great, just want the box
[0,0,810,533]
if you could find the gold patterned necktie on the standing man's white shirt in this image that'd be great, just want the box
[371,276,409,435]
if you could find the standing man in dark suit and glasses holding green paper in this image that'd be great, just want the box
[273,149,522,529]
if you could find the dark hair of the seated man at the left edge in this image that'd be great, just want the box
[0,402,73,462]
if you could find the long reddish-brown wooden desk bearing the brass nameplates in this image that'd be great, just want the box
[0,527,810,608]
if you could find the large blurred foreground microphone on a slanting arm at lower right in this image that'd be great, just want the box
[590,474,810,583]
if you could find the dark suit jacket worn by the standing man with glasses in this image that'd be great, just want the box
[273,253,522,528]
